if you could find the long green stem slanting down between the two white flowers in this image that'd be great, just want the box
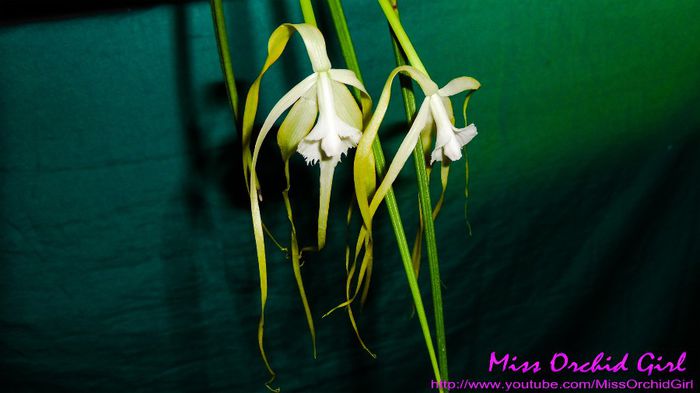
[328,0,447,392]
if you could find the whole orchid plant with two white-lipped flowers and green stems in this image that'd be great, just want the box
[211,0,480,390]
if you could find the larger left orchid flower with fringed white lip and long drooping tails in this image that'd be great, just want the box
[242,24,371,387]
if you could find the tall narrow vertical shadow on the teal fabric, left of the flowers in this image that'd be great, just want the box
[161,5,211,393]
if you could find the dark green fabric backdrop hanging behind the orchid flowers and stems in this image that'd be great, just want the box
[0,0,700,392]
